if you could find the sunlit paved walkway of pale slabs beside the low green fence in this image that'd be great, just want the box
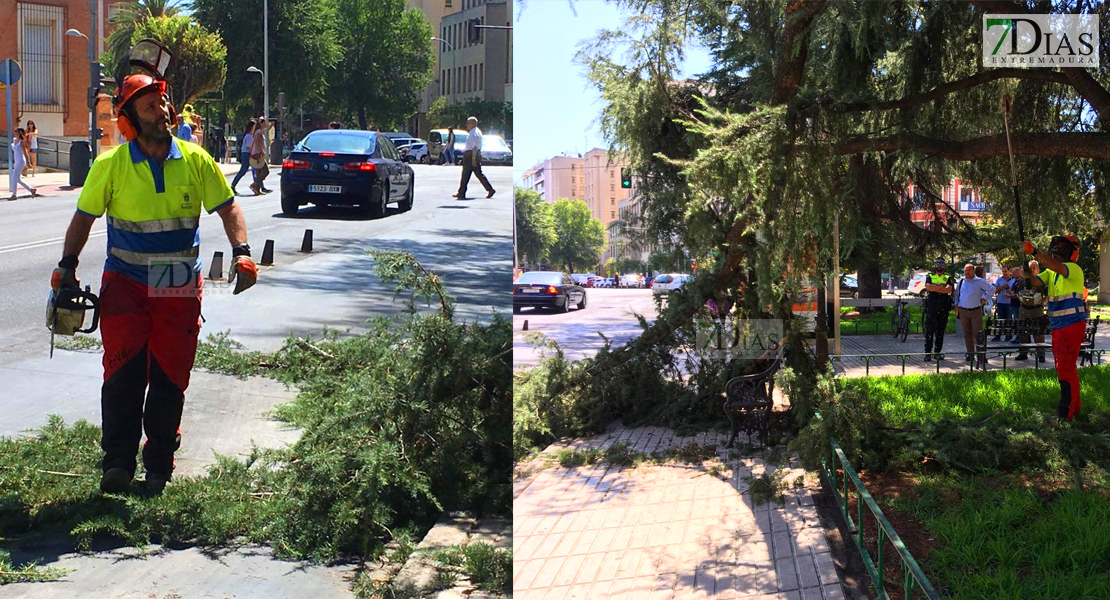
[513,426,844,600]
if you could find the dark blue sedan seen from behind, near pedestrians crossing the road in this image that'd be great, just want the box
[281,129,415,216]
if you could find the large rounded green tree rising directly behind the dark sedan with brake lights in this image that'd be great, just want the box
[329,0,435,129]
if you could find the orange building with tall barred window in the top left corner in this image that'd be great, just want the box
[0,0,123,142]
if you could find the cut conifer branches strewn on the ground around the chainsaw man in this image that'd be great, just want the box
[0,253,512,590]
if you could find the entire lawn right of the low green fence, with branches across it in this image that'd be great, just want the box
[844,366,1110,600]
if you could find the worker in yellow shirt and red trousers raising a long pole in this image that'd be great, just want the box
[1025,235,1087,420]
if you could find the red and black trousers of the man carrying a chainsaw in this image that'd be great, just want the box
[100,272,202,479]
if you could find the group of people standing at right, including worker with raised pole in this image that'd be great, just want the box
[925,235,1087,419]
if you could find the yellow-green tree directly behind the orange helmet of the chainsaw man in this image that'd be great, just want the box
[131,14,228,110]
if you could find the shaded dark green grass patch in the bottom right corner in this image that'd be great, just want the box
[894,475,1110,600]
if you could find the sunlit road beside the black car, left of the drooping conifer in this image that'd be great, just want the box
[513,288,656,368]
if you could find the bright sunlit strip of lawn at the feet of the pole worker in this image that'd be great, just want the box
[846,366,1110,426]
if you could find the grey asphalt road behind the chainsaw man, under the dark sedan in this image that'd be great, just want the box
[0,165,513,368]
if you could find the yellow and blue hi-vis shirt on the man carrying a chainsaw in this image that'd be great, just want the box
[77,139,235,287]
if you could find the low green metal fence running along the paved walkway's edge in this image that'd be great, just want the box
[816,432,940,600]
